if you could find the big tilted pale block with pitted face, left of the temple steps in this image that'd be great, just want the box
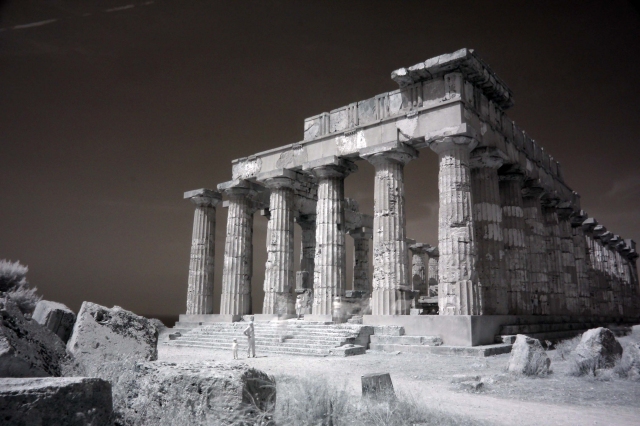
[67,302,158,376]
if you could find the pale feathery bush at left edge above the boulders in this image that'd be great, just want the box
[0,259,42,315]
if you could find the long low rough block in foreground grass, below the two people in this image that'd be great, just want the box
[98,361,276,426]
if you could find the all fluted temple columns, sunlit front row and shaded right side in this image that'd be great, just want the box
[185,136,638,315]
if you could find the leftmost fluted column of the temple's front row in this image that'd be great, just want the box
[184,189,222,315]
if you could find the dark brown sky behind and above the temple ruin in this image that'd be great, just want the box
[0,0,640,322]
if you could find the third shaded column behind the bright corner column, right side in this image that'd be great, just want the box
[522,181,549,315]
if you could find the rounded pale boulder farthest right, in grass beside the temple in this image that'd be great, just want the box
[574,327,622,369]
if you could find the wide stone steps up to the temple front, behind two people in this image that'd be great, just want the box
[166,320,373,358]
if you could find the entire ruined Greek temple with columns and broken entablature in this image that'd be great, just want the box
[176,49,640,346]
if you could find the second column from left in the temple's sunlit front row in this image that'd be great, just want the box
[218,180,257,315]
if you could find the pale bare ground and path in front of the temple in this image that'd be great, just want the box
[158,337,640,425]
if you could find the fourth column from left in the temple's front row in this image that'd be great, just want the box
[305,158,357,315]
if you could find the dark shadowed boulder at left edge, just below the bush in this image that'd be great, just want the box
[0,298,67,377]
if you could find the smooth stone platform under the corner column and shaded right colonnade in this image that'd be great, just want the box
[362,315,637,346]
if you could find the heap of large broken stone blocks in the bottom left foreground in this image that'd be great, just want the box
[0,299,275,426]
